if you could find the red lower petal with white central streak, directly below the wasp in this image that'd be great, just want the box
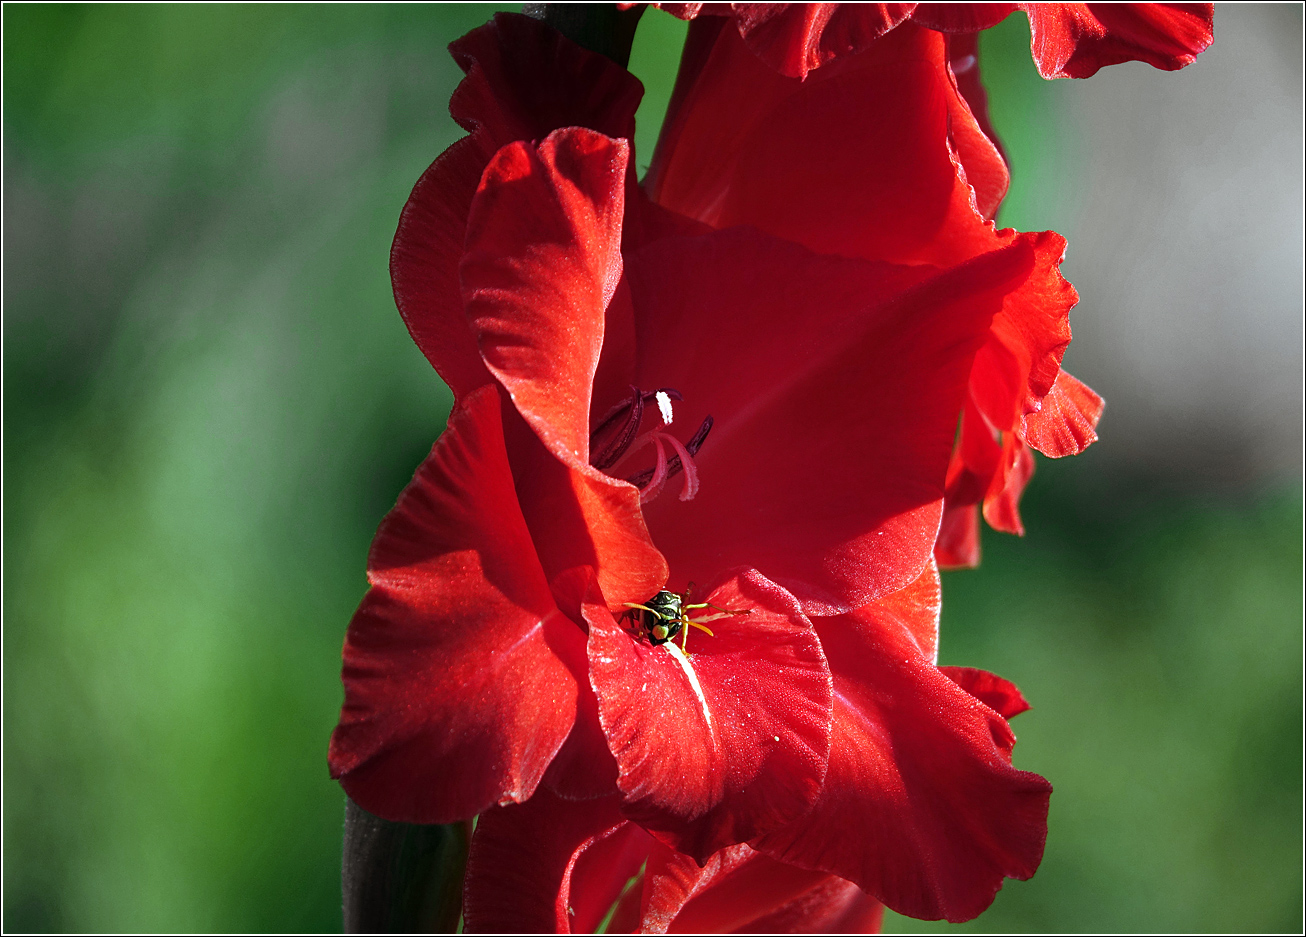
[585,571,831,859]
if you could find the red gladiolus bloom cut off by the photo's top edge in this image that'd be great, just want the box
[642,3,1213,78]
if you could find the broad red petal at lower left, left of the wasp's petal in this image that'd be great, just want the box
[329,387,584,823]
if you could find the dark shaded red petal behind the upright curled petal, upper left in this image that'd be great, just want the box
[390,13,644,396]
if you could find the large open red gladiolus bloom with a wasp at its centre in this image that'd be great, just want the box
[330,16,1050,929]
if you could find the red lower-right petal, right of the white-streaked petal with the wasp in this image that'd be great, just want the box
[754,588,1051,921]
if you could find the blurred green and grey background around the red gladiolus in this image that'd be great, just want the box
[3,5,1302,932]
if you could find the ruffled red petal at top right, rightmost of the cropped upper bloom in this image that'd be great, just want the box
[1020,3,1213,78]
